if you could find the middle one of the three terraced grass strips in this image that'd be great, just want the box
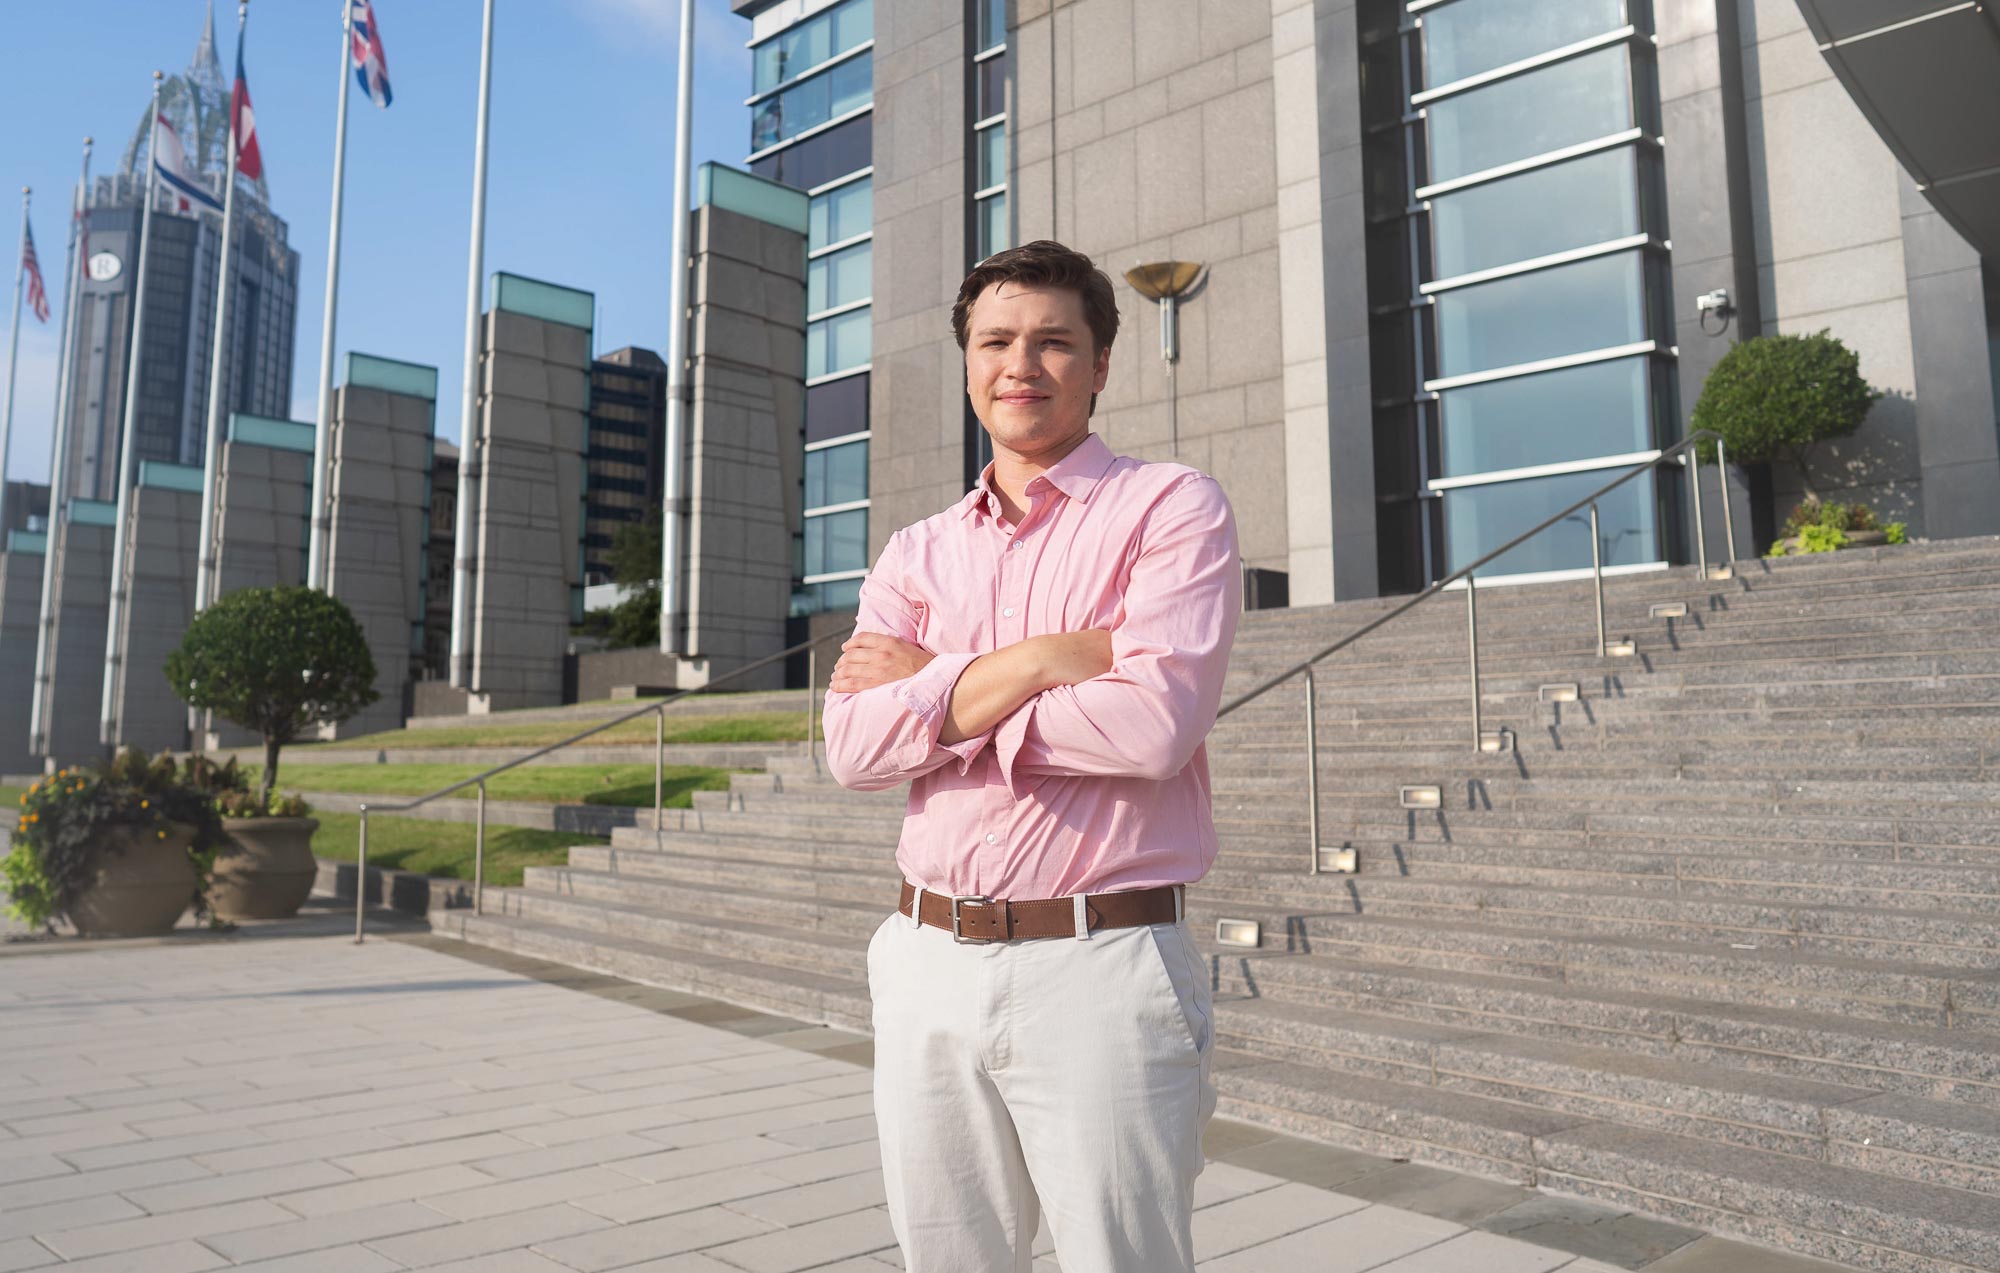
[258,759,730,809]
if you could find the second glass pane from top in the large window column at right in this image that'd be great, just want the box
[1424,46,1632,182]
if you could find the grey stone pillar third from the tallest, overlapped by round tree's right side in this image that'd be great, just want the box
[320,384,434,739]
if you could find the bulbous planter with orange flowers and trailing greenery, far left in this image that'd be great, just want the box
[0,751,222,937]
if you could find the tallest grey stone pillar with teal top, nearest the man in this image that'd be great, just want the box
[684,206,806,689]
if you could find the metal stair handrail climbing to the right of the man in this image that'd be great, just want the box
[1216,428,1736,875]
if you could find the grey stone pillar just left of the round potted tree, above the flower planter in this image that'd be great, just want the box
[112,486,202,753]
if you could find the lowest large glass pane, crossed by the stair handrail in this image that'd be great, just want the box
[1444,468,1660,578]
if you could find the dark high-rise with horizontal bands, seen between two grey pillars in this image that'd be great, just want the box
[584,346,666,584]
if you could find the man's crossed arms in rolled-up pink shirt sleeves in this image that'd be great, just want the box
[826,474,1242,791]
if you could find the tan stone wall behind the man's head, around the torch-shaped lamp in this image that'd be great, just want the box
[1008,0,1288,570]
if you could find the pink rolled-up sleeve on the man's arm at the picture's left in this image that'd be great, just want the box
[824,536,992,791]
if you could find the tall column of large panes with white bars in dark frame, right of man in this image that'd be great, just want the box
[1360,0,1678,590]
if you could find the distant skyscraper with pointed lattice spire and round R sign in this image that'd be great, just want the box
[70,12,298,500]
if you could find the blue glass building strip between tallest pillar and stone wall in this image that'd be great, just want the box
[748,0,874,616]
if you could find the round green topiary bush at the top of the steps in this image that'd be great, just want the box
[1690,330,1882,532]
